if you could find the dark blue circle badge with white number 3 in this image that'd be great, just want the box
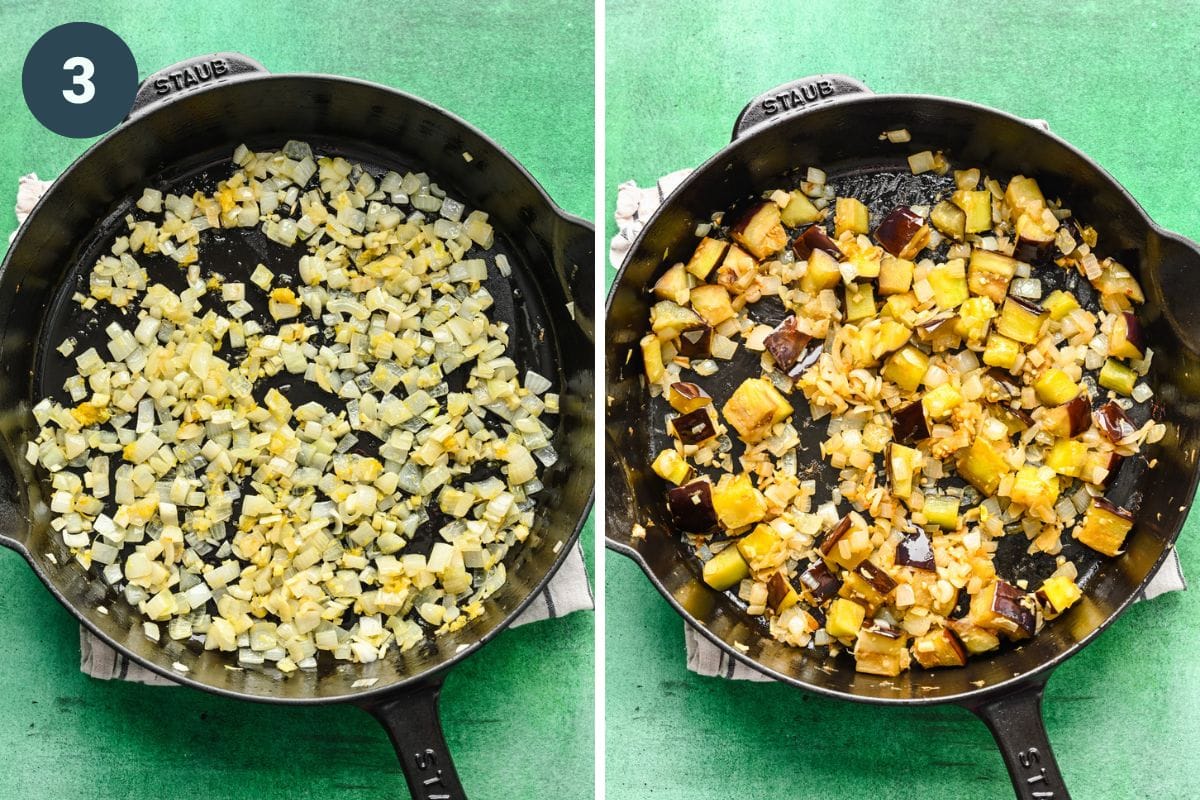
[20,23,138,139]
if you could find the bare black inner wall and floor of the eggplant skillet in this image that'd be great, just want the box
[607,97,1200,702]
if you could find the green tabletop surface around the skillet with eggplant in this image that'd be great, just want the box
[606,0,1200,800]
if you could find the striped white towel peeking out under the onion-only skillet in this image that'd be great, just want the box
[16,174,594,686]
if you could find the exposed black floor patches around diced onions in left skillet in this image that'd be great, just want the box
[34,138,563,650]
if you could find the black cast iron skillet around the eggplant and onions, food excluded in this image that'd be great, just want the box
[605,76,1200,799]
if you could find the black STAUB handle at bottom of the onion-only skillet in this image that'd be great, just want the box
[362,675,467,800]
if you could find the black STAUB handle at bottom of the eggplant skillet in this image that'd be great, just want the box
[966,675,1070,800]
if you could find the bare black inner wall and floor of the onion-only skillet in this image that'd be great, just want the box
[0,76,592,702]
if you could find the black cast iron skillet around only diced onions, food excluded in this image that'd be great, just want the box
[0,53,595,799]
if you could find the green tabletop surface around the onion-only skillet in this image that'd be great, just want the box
[0,0,594,800]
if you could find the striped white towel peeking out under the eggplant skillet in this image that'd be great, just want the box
[608,169,1188,681]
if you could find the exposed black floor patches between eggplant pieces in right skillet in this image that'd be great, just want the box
[646,163,1153,654]
